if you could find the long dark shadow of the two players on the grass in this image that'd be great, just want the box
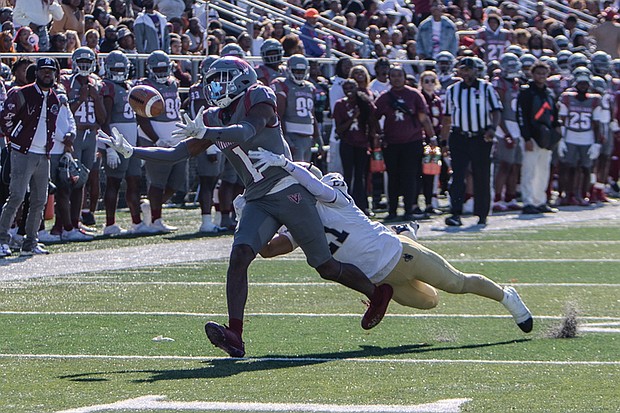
[59,338,531,383]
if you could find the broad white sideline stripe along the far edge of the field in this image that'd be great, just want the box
[0,203,620,282]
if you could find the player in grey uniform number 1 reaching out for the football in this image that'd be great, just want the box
[101,56,392,357]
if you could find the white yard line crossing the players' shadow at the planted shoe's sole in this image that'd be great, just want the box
[0,353,620,366]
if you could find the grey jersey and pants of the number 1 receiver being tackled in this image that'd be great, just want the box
[204,84,331,267]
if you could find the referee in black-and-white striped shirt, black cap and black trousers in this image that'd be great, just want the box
[441,57,502,227]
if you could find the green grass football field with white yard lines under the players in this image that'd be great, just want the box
[0,210,620,413]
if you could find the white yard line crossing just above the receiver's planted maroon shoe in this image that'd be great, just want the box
[0,311,620,322]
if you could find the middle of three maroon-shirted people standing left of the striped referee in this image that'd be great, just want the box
[376,65,437,221]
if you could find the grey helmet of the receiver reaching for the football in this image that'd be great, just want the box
[202,56,258,108]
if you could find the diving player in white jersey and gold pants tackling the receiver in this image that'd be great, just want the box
[249,148,533,333]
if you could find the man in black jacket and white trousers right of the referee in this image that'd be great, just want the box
[517,62,561,214]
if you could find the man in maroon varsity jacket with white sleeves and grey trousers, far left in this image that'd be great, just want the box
[0,57,60,257]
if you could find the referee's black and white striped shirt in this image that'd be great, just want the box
[444,79,503,133]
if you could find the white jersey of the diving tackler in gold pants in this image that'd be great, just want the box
[316,190,403,283]
